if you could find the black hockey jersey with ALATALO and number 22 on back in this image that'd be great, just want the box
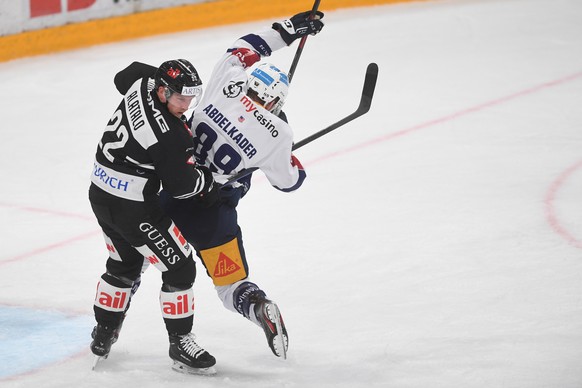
[91,62,203,201]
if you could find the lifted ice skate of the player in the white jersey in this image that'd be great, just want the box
[254,297,289,359]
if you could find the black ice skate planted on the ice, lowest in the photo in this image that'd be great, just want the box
[170,333,216,375]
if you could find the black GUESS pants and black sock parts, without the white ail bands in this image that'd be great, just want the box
[89,184,196,333]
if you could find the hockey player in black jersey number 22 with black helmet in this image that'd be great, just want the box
[89,59,217,373]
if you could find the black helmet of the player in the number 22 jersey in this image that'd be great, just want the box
[154,59,202,96]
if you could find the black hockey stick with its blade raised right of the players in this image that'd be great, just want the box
[223,63,378,186]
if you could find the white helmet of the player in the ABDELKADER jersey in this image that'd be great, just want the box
[248,63,289,115]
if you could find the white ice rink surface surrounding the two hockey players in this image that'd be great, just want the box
[0,0,582,388]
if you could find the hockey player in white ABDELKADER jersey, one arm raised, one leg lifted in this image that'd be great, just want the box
[160,11,323,358]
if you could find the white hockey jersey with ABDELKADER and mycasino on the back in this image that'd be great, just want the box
[191,29,305,191]
